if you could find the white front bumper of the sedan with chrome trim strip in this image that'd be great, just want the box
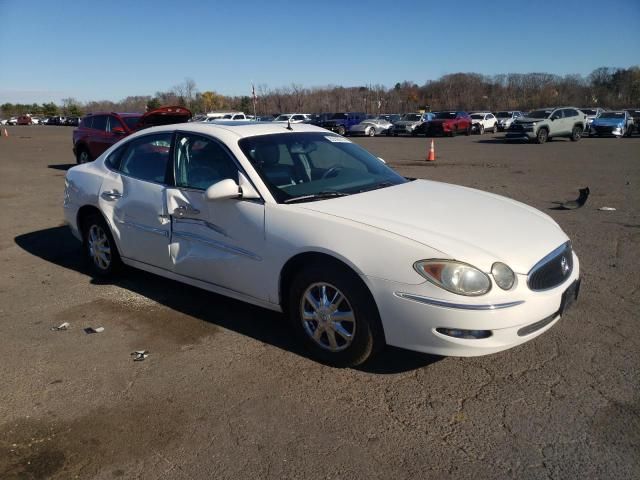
[366,254,580,357]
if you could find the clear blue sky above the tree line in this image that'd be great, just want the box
[0,0,640,103]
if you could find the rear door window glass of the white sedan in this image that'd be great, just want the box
[119,132,173,183]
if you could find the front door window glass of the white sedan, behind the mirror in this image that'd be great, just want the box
[174,133,238,190]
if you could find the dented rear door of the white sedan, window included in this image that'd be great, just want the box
[99,132,173,270]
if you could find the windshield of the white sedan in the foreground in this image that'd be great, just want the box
[238,132,407,203]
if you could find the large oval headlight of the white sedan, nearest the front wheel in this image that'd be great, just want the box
[413,260,491,297]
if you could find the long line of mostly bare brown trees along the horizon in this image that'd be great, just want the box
[0,66,640,116]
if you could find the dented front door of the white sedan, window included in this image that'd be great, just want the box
[167,132,268,300]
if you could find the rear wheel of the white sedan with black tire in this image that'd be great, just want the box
[82,213,122,277]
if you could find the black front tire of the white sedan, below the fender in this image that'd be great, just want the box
[287,263,385,367]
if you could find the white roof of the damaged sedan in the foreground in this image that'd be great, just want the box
[131,121,335,139]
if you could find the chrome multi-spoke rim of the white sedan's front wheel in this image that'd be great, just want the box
[300,282,356,352]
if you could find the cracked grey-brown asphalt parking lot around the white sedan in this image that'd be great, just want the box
[0,126,640,479]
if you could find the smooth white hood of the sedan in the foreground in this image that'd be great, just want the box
[298,180,568,274]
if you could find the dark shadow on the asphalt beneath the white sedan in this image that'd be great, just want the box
[14,226,440,374]
